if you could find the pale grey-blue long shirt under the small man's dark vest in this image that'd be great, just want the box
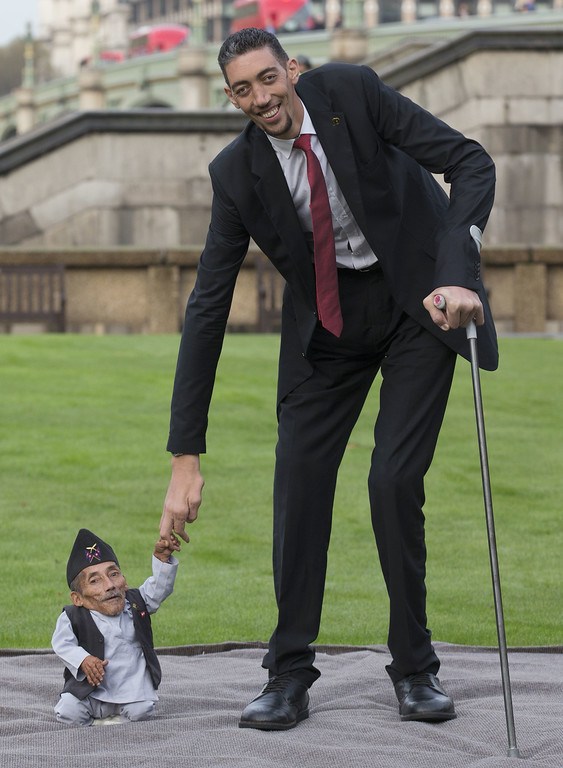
[51,555,178,704]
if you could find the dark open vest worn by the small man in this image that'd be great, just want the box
[63,589,162,699]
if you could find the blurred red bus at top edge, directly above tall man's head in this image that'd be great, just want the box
[231,0,323,32]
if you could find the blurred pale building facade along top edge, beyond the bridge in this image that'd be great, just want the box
[37,0,563,77]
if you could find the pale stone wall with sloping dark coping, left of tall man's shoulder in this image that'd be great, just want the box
[0,112,247,248]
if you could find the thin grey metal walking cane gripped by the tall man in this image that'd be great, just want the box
[433,227,521,757]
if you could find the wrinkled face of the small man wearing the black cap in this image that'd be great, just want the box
[70,563,127,616]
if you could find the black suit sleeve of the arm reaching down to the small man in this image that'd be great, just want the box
[167,163,249,454]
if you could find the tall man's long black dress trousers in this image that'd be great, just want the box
[263,270,456,685]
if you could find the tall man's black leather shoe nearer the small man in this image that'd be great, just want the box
[239,674,309,731]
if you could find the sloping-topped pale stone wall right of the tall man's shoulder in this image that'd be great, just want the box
[382,29,563,246]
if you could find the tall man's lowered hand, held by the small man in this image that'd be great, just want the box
[160,454,204,541]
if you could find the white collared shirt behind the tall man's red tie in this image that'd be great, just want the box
[266,102,377,269]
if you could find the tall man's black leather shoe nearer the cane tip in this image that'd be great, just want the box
[395,672,456,722]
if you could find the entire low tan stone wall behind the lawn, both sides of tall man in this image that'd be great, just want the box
[0,246,563,334]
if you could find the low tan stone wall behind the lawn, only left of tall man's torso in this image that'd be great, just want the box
[0,246,264,334]
